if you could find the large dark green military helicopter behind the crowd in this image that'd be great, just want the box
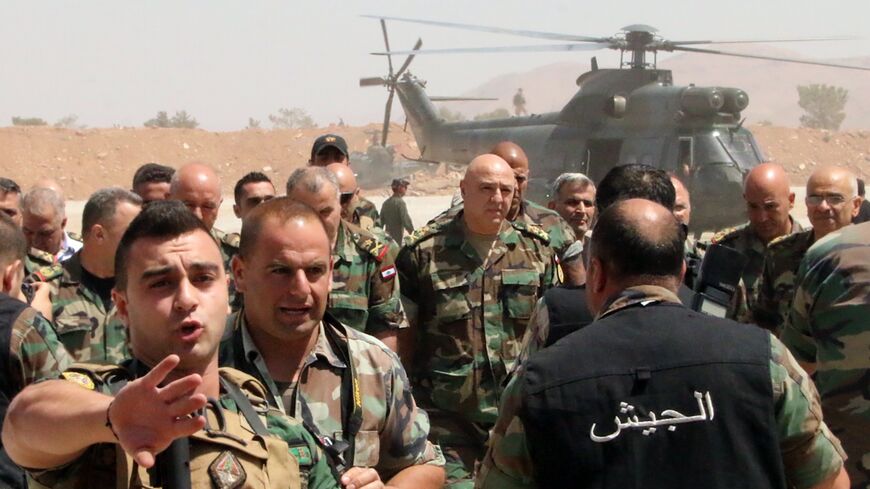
[360,15,870,233]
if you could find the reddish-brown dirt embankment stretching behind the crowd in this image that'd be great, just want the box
[0,124,870,199]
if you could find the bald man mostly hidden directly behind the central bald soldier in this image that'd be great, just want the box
[432,141,578,257]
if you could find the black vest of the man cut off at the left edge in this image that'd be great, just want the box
[0,293,27,488]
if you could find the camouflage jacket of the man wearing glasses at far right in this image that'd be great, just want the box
[752,229,815,335]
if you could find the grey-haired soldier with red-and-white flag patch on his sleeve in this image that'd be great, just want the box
[287,168,408,351]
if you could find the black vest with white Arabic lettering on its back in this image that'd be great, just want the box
[520,303,786,489]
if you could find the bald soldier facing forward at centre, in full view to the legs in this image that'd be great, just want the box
[397,154,555,488]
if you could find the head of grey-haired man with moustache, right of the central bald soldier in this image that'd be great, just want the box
[547,173,595,248]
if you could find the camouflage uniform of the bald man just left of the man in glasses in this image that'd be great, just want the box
[699,217,803,322]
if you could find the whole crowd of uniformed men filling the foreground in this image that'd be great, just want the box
[0,134,870,489]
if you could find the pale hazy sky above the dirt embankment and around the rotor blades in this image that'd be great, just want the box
[0,0,870,131]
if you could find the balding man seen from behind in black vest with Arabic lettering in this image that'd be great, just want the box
[476,199,848,489]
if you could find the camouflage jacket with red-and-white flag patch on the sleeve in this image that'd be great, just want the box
[328,220,408,335]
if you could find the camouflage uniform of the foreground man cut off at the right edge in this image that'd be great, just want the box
[782,223,870,488]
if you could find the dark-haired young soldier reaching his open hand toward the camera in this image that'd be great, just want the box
[3,202,338,489]
